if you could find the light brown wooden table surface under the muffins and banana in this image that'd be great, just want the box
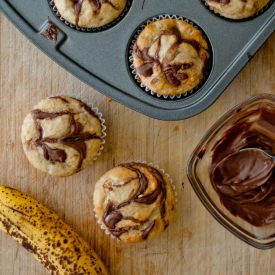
[0,15,275,275]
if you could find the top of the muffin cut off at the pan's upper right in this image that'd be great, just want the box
[205,0,270,19]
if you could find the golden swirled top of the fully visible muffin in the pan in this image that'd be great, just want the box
[133,19,210,96]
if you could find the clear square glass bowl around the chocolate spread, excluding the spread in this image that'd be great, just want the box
[187,94,275,249]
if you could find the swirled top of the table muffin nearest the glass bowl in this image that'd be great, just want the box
[94,162,175,242]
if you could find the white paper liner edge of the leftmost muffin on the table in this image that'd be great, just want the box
[50,94,107,161]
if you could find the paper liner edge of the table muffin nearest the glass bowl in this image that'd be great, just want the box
[93,160,178,242]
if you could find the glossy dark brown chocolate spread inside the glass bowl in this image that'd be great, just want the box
[210,104,275,226]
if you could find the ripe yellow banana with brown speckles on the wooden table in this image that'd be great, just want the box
[0,185,108,275]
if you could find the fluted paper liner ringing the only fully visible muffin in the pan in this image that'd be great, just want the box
[127,14,213,100]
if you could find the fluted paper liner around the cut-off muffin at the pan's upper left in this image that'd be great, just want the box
[48,0,133,33]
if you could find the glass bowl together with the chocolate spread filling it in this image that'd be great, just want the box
[187,94,275,249]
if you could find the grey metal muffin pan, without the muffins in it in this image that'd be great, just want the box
[0,0,275,120]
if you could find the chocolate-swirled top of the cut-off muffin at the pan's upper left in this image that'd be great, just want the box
[54,0,127,28]
